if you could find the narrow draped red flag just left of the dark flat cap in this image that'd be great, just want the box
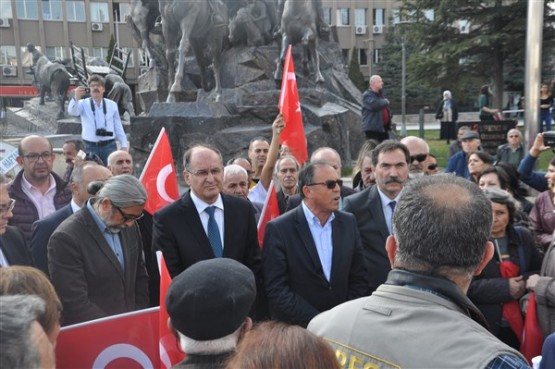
[156,251,185,369]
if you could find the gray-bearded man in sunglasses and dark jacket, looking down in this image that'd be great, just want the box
[48,174,148,324]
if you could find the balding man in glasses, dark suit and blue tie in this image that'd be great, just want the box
[152,145,261,281]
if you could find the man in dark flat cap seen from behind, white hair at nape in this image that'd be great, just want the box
[166,258,256,369]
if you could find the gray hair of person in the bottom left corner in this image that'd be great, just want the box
[0,295,45,368]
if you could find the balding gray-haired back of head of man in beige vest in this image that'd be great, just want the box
[393,175,492,277]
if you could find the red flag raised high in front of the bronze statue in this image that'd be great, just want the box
[278,45,308,165]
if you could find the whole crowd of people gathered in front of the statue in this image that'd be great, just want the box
[0,76,555,368]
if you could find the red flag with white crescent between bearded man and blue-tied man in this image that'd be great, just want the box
[140,128,179,214]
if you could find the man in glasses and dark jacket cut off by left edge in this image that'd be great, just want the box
[0,173,33,267]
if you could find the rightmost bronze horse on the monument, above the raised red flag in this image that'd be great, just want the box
[274,0,324,83]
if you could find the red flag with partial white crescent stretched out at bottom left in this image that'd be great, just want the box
[56,307,160,369]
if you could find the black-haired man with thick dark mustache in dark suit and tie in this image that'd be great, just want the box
[344,140,410,292]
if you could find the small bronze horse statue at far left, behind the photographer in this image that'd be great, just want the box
[27,44,72,119]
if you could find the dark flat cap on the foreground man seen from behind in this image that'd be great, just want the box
[166,258,256,341]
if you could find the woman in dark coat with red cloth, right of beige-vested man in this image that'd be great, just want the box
[468,188,542,349]
